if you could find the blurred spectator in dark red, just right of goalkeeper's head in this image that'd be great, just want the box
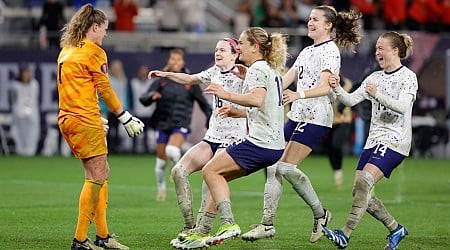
[113,0,139,32]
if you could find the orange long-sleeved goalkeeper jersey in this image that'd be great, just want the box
[57,39,121,127]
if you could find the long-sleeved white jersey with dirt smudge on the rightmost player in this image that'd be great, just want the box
[340,66,418,156]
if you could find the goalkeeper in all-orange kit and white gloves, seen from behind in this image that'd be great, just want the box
[57,4,144,250]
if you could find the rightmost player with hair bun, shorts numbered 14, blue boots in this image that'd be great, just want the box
[323,31,418,250]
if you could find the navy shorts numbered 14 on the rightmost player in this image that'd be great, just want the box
[356,144,406,179]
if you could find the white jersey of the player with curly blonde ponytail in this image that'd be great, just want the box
[244,61,284,149]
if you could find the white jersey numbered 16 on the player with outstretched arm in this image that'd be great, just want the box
[195,66,247,147]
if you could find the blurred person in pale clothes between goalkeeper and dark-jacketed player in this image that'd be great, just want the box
[130,65,156,153]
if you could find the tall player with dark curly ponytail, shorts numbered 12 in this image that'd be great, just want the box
[242,5,361,243]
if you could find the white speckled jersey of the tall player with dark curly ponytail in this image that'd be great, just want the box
[287,40,341,127]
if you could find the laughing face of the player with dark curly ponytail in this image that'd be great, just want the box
[308,9,332,43]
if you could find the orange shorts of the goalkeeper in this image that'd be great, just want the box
[58,117,108,159]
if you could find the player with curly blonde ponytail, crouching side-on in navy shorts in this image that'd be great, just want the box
[202,27,287,245]
